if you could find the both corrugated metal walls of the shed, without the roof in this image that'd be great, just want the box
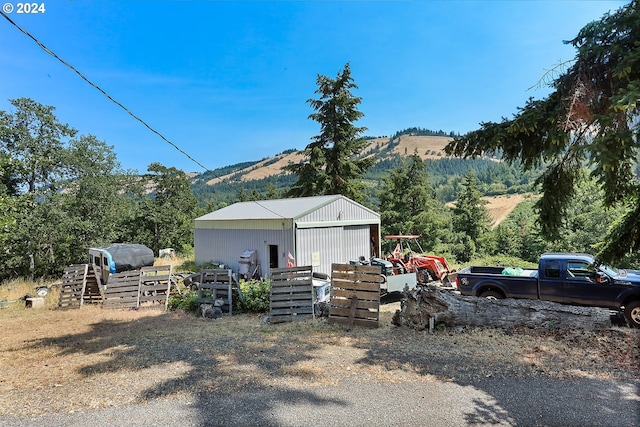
[194,198,380,276]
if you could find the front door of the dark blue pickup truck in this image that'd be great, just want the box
[564,261,621,308]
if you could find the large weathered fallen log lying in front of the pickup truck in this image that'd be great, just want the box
[392,285,611,330]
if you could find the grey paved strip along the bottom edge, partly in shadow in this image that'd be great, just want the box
[2,377,640,427]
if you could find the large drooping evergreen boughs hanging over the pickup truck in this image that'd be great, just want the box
[446,0,640,261]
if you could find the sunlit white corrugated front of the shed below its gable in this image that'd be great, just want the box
[296,225,371,274]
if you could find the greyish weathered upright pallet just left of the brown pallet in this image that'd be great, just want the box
[269,266,314,323]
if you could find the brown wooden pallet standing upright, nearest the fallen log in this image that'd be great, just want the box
[328,264,380,329]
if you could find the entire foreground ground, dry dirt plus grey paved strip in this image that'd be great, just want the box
[0,307,640,427]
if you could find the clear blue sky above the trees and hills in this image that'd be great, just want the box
[0,0,626,172]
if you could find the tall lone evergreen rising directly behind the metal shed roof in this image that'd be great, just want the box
[283,64,374,201]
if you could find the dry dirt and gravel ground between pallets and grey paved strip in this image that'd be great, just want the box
[0,303,640,416]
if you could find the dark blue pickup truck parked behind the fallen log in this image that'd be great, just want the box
[456,253,640,328]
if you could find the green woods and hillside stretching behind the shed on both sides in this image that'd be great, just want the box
[0,99,634,280]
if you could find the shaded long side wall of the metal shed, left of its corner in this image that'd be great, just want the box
[194,228,294,276]
